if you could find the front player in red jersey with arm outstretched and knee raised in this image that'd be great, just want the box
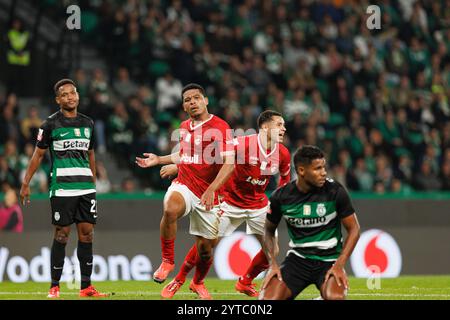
[136,83,234,299]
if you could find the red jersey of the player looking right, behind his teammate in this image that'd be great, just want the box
[223,134,291,209]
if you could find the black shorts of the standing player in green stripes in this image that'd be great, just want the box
[50,192,97,226]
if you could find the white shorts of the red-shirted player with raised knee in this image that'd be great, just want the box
[164,182,219,239]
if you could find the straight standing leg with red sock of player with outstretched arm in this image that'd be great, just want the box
[189,236,218,300]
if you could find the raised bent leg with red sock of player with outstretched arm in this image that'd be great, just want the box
[153,191,186,283]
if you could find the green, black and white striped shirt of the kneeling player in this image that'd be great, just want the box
[267,179,355,261]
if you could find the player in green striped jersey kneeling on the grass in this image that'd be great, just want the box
[260,146,360,300]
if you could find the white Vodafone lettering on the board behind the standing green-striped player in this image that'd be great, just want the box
[0,247,152,282]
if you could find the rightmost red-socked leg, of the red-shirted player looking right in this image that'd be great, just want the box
[234,234,279,297]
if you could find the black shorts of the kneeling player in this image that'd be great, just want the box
[281,253,334,299]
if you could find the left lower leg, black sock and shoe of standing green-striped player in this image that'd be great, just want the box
[47,226,70,298]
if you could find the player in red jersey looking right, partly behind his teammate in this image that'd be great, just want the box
[161,110,290,298]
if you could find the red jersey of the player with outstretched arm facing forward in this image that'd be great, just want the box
[174,115,233,203]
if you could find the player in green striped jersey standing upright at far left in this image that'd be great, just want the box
[20,79,106,298]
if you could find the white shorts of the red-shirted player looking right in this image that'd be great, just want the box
[219,201,270,237]
